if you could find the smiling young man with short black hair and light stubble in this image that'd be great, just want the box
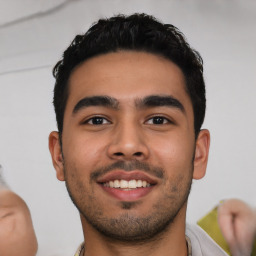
[49,14,226,256]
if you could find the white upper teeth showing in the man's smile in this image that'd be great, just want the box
[103,180,151,190]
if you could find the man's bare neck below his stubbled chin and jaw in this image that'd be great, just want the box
[81,212,188,256]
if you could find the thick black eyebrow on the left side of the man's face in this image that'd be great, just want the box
[73,96,119,114]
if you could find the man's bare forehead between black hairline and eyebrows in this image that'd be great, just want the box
[67,51,190,108]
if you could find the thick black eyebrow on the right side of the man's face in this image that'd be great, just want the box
[136,95,185,113]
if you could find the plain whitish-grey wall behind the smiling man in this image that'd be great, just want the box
[0,0,256,256]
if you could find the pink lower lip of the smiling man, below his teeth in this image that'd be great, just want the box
[100,185,154,201]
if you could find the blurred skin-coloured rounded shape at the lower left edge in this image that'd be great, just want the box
[0,190,38,256]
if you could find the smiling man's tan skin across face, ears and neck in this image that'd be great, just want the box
[49,51,210,256]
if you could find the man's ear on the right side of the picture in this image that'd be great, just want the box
[193,130,210,180]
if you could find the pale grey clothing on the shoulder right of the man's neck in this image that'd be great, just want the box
[186,224,228,256]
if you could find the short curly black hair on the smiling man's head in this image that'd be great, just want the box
[53,14,206,137]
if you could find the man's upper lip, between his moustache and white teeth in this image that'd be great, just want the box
[97,170,157,184]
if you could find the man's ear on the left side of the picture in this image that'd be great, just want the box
[49,132,65,181]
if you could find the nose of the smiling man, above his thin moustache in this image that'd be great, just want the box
[107,121,149,160]
